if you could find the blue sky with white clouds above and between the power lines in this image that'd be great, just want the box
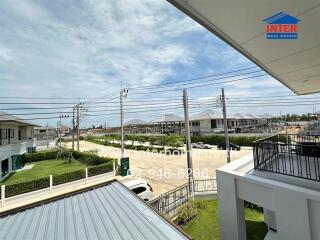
[0,0,312,126]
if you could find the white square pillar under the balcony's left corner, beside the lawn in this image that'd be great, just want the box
[216,171,247,240]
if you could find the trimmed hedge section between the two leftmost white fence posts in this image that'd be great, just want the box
[6,177,50,198]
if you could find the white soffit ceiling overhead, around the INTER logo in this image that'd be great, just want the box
[168,0,320,94]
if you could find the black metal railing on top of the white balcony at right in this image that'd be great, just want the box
[253,134,320,181]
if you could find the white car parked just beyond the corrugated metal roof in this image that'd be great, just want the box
[123,178,154,202]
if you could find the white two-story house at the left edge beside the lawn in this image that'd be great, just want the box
[0,112,37,180]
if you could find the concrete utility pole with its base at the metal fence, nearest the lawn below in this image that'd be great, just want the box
[183,89,193,194]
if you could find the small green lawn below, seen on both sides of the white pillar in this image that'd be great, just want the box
[182,200,267,240]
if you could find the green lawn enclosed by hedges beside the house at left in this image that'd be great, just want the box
[1,160,86,185]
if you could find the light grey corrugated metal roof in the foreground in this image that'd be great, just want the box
[0,181,189,240]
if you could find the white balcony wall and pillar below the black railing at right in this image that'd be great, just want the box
[217,156,320,240]
